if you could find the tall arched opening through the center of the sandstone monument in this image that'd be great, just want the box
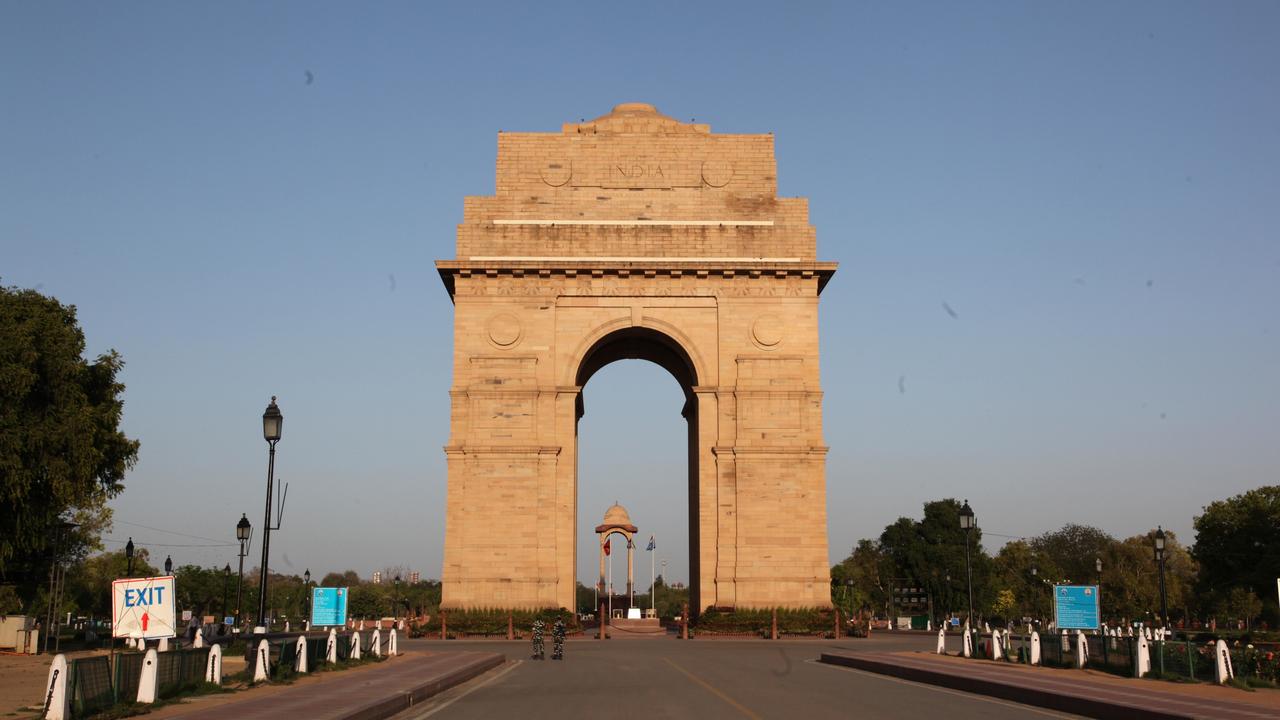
[575,327,700,612]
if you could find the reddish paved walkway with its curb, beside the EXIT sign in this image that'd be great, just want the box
[161,651,506,720]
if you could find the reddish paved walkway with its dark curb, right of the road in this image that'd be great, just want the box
[820,652,1280,720]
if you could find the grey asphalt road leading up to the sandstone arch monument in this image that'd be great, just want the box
[397,635,1069,720]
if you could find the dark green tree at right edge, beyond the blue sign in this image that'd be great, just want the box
[1192,486,1280,620]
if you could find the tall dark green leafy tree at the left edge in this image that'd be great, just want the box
[0,287,138,593]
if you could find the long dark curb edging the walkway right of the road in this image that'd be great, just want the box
[818,652,1196,720]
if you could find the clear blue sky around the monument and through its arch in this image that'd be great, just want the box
[0,1,1280,585]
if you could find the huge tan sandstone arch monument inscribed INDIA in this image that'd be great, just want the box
[436,102,836,612]
